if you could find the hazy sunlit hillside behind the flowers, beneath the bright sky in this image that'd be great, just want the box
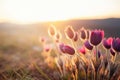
[0,18,120,37]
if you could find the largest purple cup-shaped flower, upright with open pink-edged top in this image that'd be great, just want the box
[90,30,104,46]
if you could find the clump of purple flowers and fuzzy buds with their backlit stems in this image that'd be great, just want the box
[48,26,120,80]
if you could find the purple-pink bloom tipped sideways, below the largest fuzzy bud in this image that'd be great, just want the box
[59,44,75,55]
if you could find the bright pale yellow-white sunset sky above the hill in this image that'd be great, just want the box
[0,0,120,23]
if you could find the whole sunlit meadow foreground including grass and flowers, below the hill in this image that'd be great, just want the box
[0,25,120,80]
